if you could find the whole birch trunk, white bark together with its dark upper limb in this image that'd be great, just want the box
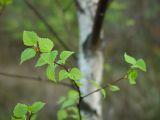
[77,0,108,120]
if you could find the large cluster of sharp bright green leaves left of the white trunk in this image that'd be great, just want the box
[21,31,81,82]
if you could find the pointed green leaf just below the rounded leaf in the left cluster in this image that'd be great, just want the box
[36,50,58,67]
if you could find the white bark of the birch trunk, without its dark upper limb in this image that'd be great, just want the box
[78,0,103,120]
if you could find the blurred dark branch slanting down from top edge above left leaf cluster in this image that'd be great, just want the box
[24,0,73,54]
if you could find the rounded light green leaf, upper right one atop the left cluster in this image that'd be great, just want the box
[38,38,54,52]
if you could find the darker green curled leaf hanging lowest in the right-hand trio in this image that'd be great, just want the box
[128,70,138,85]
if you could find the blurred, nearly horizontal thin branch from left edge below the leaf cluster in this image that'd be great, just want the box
[0,72,72,88]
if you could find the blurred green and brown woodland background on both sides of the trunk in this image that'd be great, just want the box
[0,0,160,120]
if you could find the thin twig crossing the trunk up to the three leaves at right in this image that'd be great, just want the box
[81,75,127,99]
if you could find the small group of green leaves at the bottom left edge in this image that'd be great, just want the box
[12,102,45,120]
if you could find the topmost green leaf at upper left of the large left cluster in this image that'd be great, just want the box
[23,31,38,46]
